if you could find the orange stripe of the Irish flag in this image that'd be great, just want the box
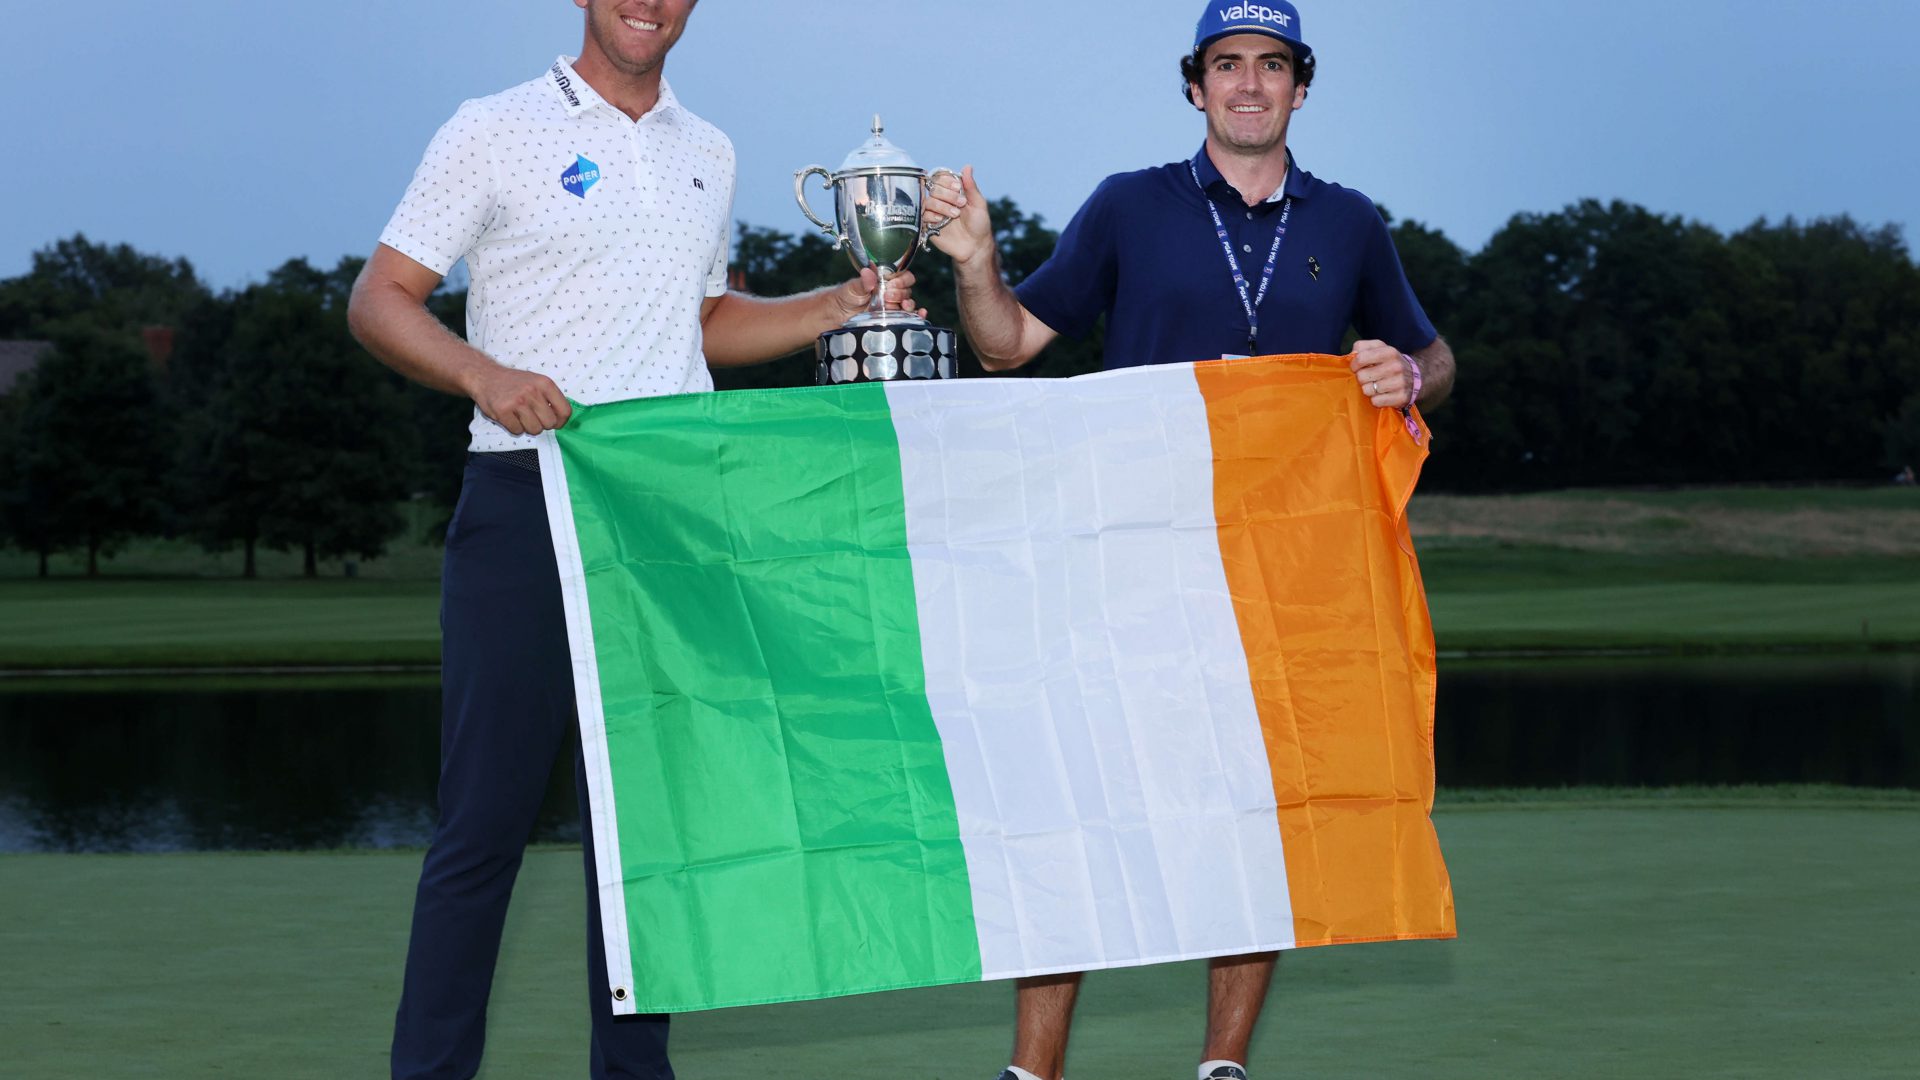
[1194,356,1453,945]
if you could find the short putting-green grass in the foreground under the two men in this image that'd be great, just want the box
[0,792,1920,1080]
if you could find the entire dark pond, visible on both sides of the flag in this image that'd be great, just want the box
[0,655,1920,851]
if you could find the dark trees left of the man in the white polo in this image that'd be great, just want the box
[0,236,467,577]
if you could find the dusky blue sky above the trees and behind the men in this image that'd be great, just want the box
[0,0,1920,288]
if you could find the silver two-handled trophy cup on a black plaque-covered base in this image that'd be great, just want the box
[793,115,956,386]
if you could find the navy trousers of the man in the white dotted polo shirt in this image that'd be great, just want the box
[394,454,674,1080]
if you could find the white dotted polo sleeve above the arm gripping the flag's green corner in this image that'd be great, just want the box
[380,102,499,275]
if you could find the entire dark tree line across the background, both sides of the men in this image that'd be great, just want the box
[0,198,1920,577]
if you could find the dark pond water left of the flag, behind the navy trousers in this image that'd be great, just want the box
[0,676,580,851]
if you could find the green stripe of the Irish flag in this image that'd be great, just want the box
[559,386,979,1011]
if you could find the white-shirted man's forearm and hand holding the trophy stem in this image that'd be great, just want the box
[701,269,925,367]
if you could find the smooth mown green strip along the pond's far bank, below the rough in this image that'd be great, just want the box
[15,548,1920,671]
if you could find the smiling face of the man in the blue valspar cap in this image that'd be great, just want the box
[1190,35,1308,156]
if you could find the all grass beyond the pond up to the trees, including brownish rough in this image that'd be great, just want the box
[0,480,1920,673]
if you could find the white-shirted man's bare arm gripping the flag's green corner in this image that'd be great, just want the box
[348,244,572,434]
